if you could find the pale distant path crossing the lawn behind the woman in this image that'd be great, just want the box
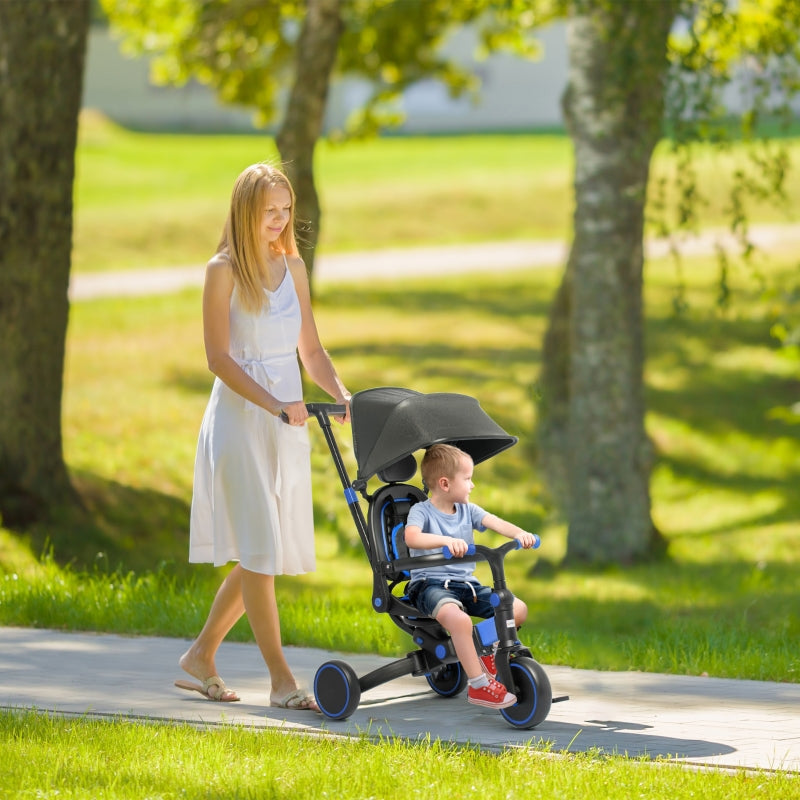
[70,225,800,300]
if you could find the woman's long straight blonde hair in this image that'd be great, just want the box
[217,162,299,311]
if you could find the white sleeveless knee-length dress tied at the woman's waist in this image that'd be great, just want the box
[189,259,316,575]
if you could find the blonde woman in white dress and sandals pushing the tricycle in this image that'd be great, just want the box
[175,164,350,710]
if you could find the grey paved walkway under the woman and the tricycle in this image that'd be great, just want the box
[0,623,800,773]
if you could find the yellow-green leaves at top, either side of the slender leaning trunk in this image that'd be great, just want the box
[101,0,545,136]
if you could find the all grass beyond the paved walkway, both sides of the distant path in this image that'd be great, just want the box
[0,1,800,800]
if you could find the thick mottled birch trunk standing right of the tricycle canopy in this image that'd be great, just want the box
[539,0,678,563]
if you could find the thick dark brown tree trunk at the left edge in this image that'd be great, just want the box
[0,0,89,526]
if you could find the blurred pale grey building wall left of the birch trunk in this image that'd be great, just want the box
[83,24,567,134]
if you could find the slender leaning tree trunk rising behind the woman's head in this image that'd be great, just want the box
[276,0,344,282]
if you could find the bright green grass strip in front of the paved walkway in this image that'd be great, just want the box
[0,712,798,800]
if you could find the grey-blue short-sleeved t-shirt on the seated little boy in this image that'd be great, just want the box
[406,500,488,583]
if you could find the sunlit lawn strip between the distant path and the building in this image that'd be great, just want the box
[73,109,800,272]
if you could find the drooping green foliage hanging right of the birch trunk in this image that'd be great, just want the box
[666,0,800,241]
